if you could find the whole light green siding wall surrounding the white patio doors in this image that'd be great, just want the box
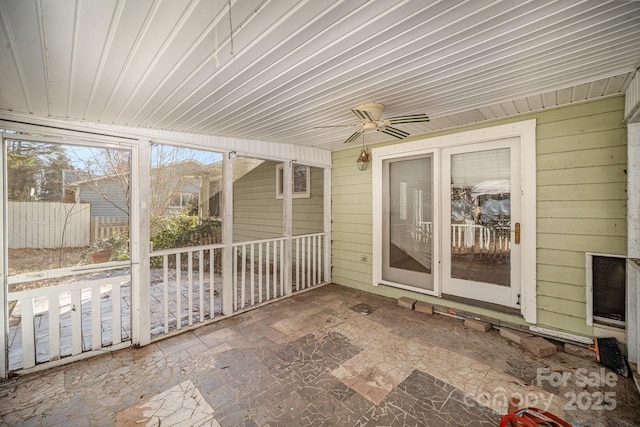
[332,97,627,335]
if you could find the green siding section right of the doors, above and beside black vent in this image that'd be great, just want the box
[537,97,627,335]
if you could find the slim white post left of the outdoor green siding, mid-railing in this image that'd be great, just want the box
[222,152,235,315]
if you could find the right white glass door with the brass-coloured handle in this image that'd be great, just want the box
[441,138,521,307]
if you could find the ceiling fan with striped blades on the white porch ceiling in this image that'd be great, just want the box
[316,102,429,144]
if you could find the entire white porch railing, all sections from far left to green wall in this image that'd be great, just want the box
[7,233,327,371]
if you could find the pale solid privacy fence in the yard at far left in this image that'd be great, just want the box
[7,202,91,249]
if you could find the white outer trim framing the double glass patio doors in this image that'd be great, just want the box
[371,119,537,324]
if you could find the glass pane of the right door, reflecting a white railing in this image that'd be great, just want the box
[451,148,511,286]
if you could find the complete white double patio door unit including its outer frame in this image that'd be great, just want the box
[372,120,537,323]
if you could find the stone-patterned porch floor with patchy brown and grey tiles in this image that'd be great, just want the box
[0,285,640,426]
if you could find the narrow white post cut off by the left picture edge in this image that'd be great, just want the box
[0,132,9,378]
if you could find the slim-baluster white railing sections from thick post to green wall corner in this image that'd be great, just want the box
[150,233,326,337]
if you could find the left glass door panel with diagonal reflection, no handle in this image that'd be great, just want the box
[382,154,434,290]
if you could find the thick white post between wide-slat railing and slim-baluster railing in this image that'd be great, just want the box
[129,139,151,346]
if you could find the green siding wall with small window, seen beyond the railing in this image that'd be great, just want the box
[233,161,324,242]
